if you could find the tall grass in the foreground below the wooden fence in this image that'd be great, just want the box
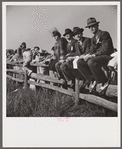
[6,80,117,117]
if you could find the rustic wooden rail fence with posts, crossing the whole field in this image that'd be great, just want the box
[6,62,118,112]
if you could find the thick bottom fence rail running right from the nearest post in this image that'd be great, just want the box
[79,93,118,112]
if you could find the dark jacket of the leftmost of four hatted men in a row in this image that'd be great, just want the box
[54,37,67,60]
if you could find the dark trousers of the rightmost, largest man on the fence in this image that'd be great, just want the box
[77,55,111,83]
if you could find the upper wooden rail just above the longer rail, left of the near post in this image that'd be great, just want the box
[30,73,63,84]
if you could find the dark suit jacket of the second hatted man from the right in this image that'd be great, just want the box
[75,37,91,56]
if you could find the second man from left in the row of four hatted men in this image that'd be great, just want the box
[55,28,76,88]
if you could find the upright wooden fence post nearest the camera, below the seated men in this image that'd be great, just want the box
[75,78,79,105]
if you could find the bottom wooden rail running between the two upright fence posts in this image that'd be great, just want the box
[28,81,75,96]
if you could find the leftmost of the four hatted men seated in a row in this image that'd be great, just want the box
[49,30,67,73]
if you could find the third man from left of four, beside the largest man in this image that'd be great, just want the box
[61,27,91,89]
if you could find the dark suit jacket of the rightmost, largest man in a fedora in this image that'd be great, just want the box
[89,30,114,56]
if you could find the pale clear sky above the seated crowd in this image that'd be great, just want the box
[6,3,117,52]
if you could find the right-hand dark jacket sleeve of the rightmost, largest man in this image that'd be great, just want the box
[94,32,113,56]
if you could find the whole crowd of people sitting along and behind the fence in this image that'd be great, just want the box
[7,17,117,93]
